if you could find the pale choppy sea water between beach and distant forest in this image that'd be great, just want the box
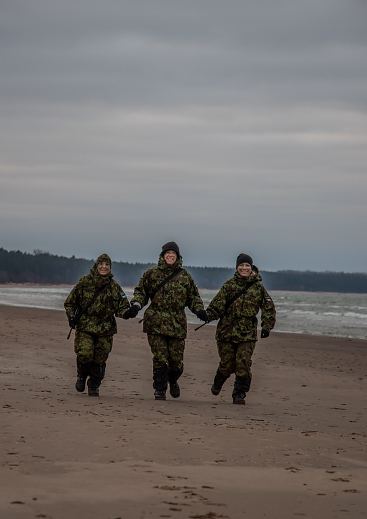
[0,285,367,339]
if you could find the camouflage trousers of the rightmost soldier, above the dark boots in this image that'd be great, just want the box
[217,341,256,382]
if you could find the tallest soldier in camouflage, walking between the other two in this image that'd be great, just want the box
[124,242,207,400]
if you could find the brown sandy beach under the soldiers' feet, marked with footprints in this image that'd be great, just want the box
[0,306,367,519]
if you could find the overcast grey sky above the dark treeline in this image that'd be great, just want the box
[0,0,367,272]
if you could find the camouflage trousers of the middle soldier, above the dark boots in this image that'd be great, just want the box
[148,334,185,373]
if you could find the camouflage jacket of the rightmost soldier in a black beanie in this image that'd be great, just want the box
[207,272,276,342]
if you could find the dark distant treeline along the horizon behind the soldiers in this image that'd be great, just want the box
[0,248,367,293]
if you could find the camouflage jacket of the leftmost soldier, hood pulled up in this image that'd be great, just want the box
[64,263,130,335]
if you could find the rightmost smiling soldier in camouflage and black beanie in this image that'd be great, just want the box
[207,253,276,404]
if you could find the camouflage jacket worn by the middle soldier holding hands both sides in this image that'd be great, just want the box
[131,257,204,339]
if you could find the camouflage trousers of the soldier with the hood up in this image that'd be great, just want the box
[74,330,113,365]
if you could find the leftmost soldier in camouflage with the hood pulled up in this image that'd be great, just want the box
[64,254,130,396]
